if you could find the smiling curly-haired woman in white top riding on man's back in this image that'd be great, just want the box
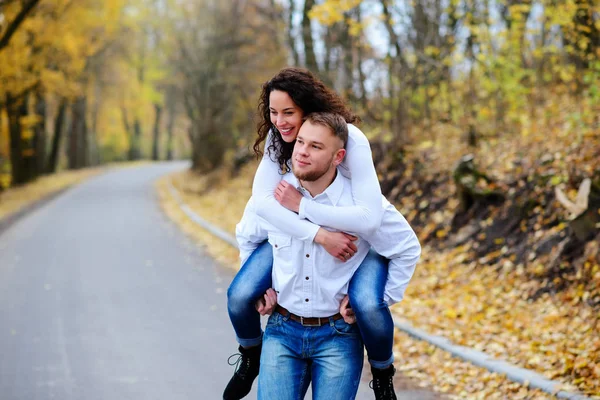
[224,68,396,399]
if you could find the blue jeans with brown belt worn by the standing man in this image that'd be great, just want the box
[258,313,363,400]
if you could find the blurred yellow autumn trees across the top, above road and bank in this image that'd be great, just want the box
[0,0,600,187]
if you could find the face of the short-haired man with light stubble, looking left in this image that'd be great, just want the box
[292,121,346,182]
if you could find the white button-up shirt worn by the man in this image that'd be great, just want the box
[236,167,421,317]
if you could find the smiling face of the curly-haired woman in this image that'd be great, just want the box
[269,90,304,143]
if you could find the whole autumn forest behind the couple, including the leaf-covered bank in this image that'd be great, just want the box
[0,0,600,396]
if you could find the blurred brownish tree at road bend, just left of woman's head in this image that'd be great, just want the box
[172,0,284,171]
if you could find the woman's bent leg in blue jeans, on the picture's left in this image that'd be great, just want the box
[227,240,273,347]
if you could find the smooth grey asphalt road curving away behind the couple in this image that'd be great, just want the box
[0,163,437,400]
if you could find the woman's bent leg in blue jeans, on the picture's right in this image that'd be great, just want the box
[348,249,394,369]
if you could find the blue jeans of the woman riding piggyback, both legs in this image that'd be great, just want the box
[227,241,394,368]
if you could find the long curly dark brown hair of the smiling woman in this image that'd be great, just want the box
[253,68,360,172]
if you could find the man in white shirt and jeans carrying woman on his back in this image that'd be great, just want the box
[237,114,420,399]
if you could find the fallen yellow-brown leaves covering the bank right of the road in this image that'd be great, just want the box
[161,124,600,399]
